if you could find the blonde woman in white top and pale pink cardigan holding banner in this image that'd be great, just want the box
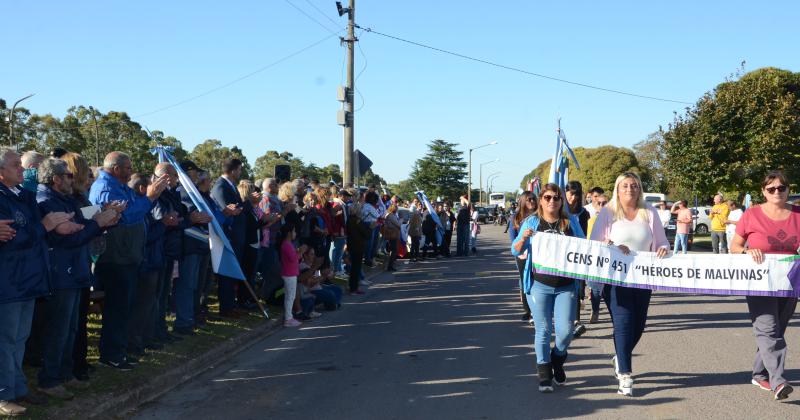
[591,172,669,396]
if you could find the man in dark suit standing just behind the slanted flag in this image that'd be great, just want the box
[211,159,247,318]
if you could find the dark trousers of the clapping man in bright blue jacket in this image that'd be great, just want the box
[95,264,139,362]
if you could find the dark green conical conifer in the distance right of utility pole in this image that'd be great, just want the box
[410,139,467,200]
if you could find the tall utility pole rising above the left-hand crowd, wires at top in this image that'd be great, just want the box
[336,0,358,185]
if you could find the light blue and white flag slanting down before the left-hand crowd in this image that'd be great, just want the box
[152,145,244,280]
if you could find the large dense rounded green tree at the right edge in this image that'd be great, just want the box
[663,67,800,199]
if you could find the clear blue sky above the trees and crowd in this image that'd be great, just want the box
[0,0,800,190]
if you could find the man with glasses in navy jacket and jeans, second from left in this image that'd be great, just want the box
[36,159,118,400]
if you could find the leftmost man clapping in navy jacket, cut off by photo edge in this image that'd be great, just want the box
[0,147,81,416]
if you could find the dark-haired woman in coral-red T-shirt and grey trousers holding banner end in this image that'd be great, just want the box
[731,171,800,400]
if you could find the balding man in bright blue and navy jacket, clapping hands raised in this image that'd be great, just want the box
[89,152,169,371]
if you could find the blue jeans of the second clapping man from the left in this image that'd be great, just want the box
[39,289,81,388]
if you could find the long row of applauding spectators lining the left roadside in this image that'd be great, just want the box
[0,148,488,415]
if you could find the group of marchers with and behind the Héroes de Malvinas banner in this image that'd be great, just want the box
[509,171,800,400]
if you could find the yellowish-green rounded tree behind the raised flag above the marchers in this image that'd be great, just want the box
[520,146,649,191]
